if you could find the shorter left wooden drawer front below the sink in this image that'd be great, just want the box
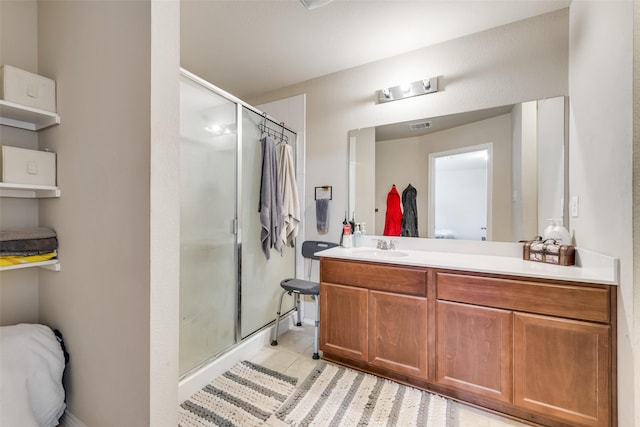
[320,258,427,297]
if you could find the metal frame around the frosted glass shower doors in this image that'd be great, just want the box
[180,67,304,372]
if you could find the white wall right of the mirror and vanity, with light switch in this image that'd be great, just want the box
[569,1,640,426]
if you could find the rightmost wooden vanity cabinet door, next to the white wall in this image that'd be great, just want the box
[514,313,611,426]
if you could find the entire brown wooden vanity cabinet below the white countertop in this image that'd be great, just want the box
[320,255,617,427]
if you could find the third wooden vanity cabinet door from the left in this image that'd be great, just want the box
[436,301,513,403]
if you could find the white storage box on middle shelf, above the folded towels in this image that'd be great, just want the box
[2,145,56,185]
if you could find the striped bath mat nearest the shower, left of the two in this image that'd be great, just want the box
[178,361,297,427]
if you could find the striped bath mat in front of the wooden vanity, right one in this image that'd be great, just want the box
[276,364,453,427]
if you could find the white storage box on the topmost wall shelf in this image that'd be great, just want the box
[0,65,56,113]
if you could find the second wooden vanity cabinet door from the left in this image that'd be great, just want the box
[369,291,427,379]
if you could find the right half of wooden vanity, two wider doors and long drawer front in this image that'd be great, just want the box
[434,271,615,426]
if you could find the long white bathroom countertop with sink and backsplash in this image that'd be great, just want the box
[317,236,618,285]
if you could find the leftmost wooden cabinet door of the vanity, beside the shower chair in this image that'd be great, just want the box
[320,282,369,362]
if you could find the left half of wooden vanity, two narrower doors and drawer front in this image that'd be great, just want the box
[320,260,427,379]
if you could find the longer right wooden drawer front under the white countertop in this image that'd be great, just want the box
[435,271,611,323]
